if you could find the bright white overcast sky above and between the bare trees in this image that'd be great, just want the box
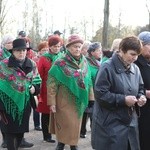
[2,0,150,38]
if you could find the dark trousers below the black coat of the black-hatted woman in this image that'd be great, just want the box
[5,133,24,150]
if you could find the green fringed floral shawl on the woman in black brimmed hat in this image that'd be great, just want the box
[0,58,41,124]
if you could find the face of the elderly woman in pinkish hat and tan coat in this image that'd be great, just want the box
[68,43,82,58]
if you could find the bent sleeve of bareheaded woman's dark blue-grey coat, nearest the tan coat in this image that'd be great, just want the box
[94,63,126,110]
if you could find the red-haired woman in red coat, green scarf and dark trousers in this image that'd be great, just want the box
[37,35,63,143]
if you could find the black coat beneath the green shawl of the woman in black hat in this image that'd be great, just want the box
[0,56,40,133]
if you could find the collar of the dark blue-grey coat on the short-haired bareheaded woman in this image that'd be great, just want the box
[111,53,135,74]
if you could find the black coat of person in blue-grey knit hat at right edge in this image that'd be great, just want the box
[135,55,150,150]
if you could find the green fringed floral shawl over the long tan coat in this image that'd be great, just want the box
[47,52,92,117]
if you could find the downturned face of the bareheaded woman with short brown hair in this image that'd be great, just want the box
[120,50,138,65]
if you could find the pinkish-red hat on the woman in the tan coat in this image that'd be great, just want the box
[66,34,83,47]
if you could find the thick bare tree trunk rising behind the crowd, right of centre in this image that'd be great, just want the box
[102,0,109,49]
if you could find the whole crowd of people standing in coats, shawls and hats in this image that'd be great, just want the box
[0,30,150,150]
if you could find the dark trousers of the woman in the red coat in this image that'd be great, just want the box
[41,113,52,140]
